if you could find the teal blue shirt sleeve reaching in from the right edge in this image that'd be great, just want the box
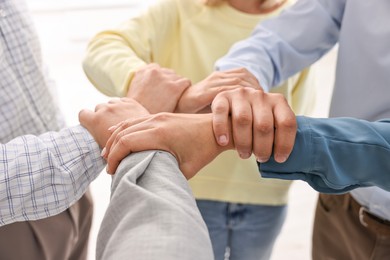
[259,117,390,193]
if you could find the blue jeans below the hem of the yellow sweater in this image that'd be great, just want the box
[197,200,287,260]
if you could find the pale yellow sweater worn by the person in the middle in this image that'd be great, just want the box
[83,0,315,205]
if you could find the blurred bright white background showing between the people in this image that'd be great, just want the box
[28,0,337,260]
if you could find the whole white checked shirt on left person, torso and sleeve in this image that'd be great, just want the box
[0,0,103,226]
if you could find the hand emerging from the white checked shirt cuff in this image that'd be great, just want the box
[79,98,149,148]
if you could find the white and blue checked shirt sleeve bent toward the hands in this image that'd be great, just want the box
[0,126,104,226]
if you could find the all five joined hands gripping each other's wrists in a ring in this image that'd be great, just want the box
[79,64,297,179]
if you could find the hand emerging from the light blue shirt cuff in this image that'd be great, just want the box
[175,68,260,113]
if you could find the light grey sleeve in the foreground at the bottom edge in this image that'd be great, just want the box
[96,151,213,260]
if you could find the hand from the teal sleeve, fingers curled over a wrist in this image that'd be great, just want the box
[211,88,297,163]
